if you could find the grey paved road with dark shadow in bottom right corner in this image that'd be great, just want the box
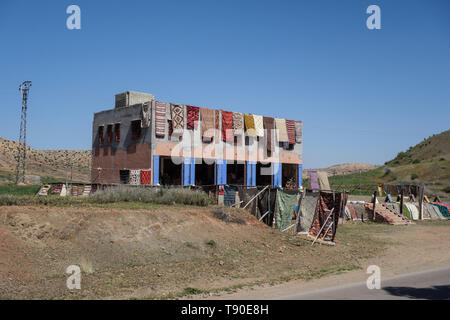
[274,267,450,300]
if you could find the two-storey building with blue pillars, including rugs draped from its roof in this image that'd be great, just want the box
[91,91,303,188]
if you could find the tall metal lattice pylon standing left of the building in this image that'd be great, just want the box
[16,81,31,184]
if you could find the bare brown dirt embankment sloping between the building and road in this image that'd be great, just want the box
[0,206,449,299]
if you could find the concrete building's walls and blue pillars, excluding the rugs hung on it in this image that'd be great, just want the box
[91,91,303,187]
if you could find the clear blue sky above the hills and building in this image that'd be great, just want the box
[0,0,450,168]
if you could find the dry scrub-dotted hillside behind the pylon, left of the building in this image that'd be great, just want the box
[0,138,91,182]
